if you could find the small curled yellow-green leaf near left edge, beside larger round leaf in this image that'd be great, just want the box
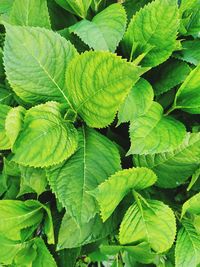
[5,106,26,147]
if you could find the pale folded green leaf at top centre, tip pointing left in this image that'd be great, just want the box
[70,4,126,52]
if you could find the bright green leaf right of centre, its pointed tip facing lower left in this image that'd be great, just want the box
[128,102,186,155]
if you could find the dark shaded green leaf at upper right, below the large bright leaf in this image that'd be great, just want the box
[152,60,191,95]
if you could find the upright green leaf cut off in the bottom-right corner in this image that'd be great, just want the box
[175,220,200,267]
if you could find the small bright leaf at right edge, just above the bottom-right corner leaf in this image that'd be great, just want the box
[181,193,200,220]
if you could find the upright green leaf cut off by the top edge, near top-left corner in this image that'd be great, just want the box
[9,0,51,29]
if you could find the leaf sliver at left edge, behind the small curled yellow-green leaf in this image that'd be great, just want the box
[0,104,11,150]
